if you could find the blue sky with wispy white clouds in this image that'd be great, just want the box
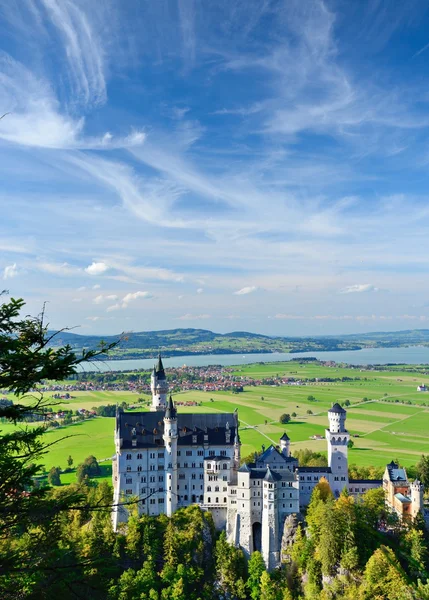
[0,0,429,336]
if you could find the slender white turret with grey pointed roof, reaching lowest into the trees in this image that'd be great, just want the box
[262,467,280,571]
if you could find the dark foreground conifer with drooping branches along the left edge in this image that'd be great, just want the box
[0,298,113,598]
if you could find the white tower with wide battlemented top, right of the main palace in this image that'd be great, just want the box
[325,403,350,497]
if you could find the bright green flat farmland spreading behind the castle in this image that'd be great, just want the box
[4,362,429,483]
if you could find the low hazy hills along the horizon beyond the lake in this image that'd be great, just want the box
[50,329,429,359]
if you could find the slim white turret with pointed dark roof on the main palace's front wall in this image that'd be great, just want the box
[163,396,178,517]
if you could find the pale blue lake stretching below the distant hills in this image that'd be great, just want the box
[78,346,429,371]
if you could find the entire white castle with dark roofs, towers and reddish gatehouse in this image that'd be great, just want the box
[112,356,423,569]
